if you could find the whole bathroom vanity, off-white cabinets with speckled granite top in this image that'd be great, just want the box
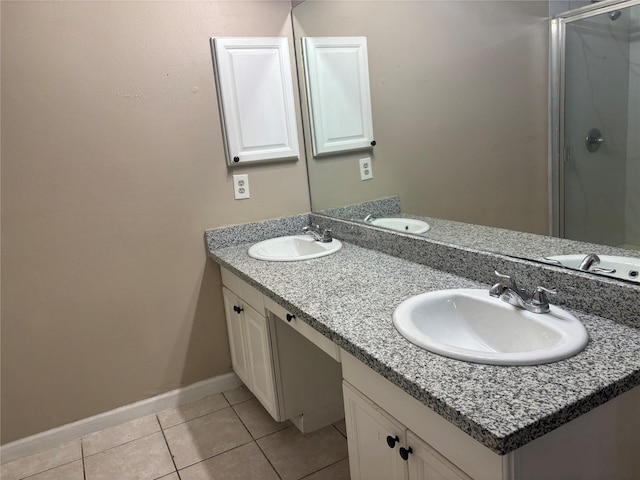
[207,216,640,479]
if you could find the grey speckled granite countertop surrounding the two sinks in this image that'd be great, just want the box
[209,241,640,454]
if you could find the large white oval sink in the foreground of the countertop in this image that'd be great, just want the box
[393,289,589,365]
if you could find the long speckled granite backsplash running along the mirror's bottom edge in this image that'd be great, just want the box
[310,213,640,328]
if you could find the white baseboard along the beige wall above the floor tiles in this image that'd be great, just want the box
[0,373,242,463]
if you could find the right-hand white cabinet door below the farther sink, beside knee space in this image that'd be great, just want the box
[244,305,280,420]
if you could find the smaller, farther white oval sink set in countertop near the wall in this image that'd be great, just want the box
[249,235,342,262]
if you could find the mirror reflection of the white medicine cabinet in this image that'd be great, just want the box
[302,37,376,156]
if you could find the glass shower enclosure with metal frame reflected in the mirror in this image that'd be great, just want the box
[550,0,640,249]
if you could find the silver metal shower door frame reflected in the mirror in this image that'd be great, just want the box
[549,0,640,238]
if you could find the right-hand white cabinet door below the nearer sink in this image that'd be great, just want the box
[407,430,471,480]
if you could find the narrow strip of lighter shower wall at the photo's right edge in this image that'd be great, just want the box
[625,6,640,249]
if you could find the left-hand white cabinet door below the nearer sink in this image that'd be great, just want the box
[342,382,407,480]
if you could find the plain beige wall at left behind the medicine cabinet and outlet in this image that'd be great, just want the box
[1,1,309,443]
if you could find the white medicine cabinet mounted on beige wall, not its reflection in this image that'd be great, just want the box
[211,38,299,166]
